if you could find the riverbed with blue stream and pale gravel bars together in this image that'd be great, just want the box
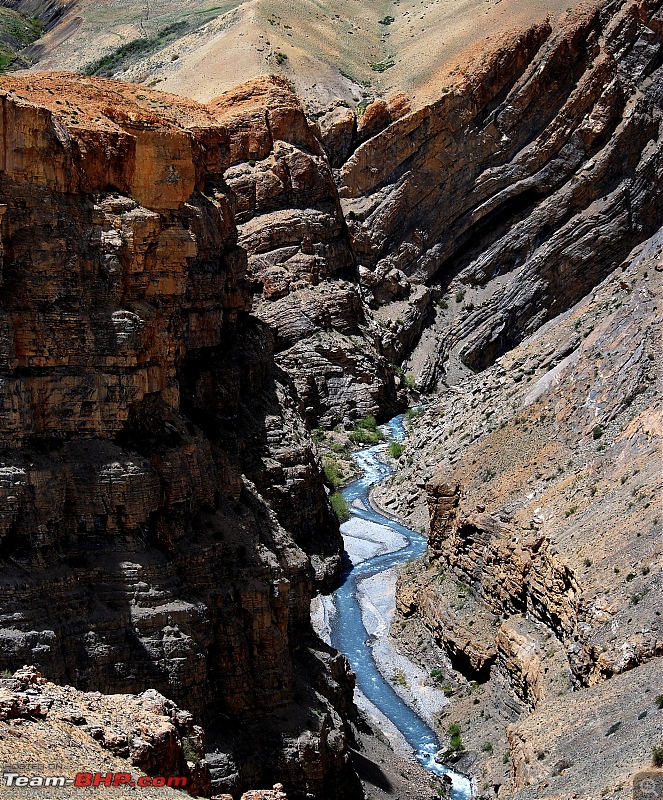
[316,416,472,800]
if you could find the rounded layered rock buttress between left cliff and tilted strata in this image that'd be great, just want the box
[210,77,405,427]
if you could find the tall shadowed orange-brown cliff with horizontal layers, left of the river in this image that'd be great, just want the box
[0,74,355,797]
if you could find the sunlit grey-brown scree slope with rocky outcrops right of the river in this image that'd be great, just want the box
[376,232,663,798]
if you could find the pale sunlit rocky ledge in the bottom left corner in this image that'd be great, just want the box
[0,667,210,800]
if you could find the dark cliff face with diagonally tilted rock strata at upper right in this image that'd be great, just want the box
[339,2,663,387]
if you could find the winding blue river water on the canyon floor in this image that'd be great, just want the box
[331,416,472,800]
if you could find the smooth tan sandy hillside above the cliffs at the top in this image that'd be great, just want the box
[26,0,584,107]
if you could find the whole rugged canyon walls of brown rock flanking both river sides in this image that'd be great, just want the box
[0,0,663,800]
